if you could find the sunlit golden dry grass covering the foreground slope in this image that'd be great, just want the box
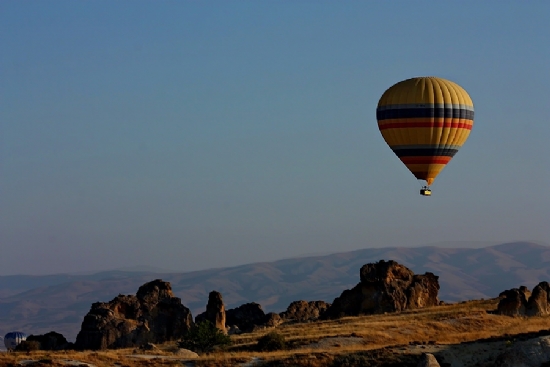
[0,299,550,367]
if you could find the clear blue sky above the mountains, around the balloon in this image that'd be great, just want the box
[0,0,550,275]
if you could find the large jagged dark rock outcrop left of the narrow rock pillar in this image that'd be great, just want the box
[75,279,193,350]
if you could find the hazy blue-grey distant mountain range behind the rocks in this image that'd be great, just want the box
[0,242,550,341]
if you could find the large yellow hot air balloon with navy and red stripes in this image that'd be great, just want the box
[376,77,474,196]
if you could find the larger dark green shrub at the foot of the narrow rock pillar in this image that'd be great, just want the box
[178,320,231,353]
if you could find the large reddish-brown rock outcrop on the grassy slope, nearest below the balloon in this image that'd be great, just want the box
[322,260,439,318]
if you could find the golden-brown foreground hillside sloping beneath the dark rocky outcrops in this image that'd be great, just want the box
[0,299,550,367]
